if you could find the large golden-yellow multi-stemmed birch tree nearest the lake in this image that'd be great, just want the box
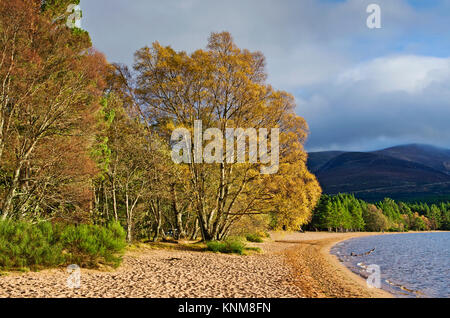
[134,32,320,240]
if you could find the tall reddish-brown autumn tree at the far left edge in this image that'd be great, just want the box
[0,0,105,219]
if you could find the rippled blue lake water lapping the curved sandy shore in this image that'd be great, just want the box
[331,232,450,298]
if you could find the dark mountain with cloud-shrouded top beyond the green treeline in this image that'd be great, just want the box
[308,144,450,201]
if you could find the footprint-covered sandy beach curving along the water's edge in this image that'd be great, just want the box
[0,233,392,298]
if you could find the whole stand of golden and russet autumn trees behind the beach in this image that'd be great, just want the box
[0,0,321,241]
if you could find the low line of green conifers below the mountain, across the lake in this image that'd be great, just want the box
[308,194,450,232]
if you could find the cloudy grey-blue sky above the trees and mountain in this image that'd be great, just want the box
[81,0,450,151]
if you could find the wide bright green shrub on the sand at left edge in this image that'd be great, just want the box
[0,220,126,270]
